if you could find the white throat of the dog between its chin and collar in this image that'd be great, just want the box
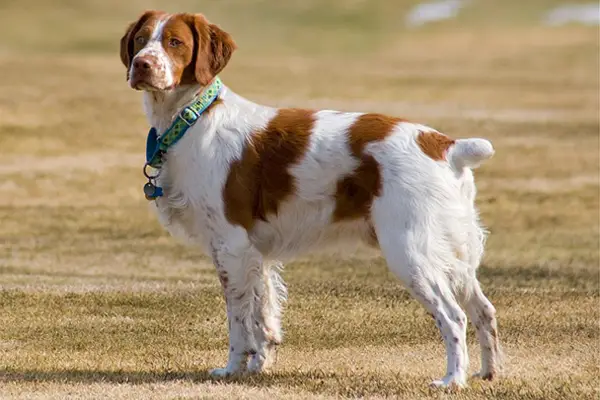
[144,84,203,134]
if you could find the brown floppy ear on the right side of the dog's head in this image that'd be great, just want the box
[190,14,237,86]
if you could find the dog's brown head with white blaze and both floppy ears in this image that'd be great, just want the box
[121,11,236,91]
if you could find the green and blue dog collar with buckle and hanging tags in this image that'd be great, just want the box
[144,77,223,200]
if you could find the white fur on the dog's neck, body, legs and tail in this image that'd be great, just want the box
[136,55,499,386]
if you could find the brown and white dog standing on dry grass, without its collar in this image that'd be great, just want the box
[121,11,499,386]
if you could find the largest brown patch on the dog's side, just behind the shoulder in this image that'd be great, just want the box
[223,109,314,230]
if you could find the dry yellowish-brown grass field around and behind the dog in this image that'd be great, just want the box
[0,0,600,399]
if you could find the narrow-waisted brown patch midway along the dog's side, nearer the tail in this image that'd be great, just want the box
[333,114,402,222]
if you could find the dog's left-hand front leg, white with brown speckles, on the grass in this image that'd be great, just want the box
[210,236,264,377]
